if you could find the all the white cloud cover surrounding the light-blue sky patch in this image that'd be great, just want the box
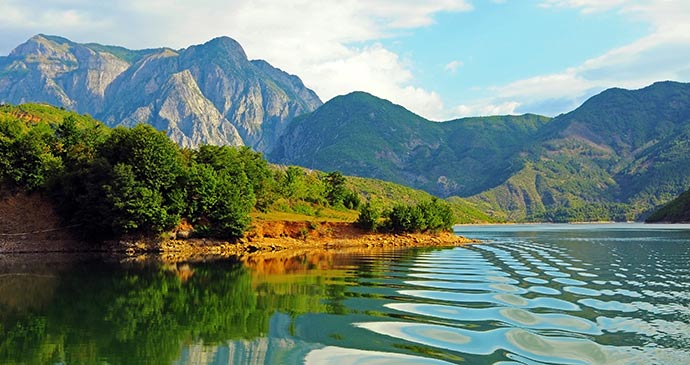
[0,0,690,120]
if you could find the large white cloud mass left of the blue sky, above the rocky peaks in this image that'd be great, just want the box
[0,0,472,117]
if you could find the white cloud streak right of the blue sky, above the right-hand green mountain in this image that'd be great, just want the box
[448,0,690,115]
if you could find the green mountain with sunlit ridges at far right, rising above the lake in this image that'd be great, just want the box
[473,82,690,221]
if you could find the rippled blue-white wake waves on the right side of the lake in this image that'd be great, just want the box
[355,228,690,364]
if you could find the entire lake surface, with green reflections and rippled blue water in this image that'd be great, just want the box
[0,224,690,365]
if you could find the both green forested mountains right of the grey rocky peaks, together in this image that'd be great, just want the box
[270,82,690,221]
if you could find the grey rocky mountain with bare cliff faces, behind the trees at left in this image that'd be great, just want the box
[0,35,321,152]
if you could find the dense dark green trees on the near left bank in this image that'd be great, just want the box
[0,105,273,239]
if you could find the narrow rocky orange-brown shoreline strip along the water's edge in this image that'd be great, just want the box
[0,220,479,263]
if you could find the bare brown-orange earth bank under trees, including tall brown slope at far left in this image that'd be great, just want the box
[0,193,474,262]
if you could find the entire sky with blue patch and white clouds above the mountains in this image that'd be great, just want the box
[0,0,690,121]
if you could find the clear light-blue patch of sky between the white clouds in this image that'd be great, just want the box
[383,1,650,115]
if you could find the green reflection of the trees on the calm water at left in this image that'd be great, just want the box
[0,261,346,365]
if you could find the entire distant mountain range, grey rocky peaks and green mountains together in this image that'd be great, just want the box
[0,35,690,221]
